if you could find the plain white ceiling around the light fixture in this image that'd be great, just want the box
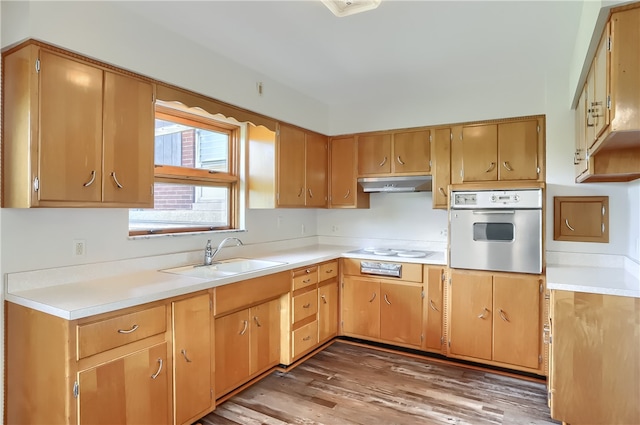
[120,0,583,106]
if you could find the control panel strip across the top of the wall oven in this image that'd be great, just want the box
[451,189,542,209]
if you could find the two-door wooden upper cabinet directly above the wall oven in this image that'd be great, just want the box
[452,117,544,183]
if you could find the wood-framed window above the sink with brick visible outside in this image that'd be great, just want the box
[129,102,241,236]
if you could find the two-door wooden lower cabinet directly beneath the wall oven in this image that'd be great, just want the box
[448,270,543,373]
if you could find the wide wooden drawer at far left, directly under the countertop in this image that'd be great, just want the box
[77,305,167,360]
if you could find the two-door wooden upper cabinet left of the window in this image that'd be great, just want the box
[3,43,154,208]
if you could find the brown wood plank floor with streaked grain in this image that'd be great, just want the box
[200,342,558,425]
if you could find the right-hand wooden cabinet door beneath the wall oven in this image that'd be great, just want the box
[493,275,542,369]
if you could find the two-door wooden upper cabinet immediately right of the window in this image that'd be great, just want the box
[247,123,329,208]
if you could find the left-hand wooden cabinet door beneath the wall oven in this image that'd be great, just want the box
[449,270,493,360]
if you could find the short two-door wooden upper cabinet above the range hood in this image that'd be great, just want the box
[357,130,431,176]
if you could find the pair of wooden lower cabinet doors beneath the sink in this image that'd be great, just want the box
[215,299,280,398]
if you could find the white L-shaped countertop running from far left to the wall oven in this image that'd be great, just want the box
[5,245,446,320]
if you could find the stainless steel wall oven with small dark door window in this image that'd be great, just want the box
[449,189,542,274]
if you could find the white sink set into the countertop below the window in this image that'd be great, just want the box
[160,258,286,279]
